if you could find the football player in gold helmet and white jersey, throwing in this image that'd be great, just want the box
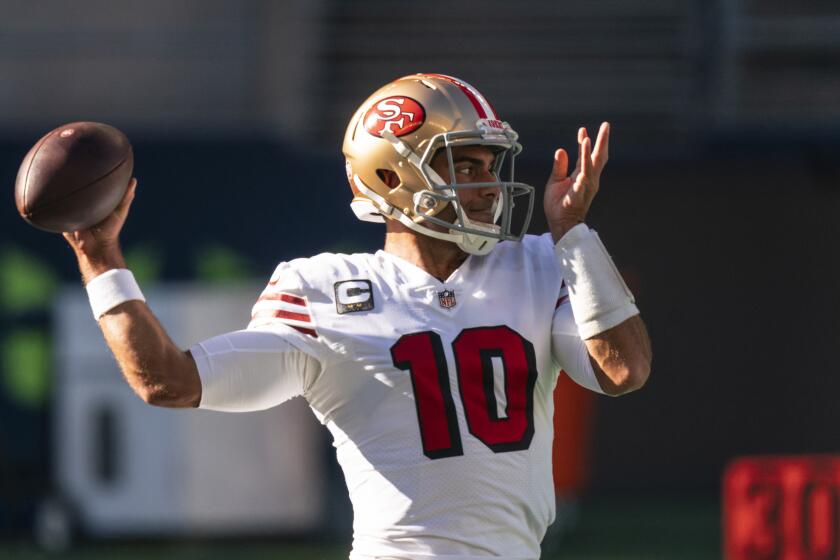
[64,74,651,560]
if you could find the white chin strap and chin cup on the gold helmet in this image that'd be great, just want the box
[350,174,502,255]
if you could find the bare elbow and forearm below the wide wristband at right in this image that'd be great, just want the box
[585,315,653,396]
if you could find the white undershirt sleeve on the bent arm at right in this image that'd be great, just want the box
[551,300,604,393]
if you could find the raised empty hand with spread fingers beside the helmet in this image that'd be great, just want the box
[543,122,610,243]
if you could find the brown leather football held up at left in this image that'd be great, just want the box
[15,122,134,232]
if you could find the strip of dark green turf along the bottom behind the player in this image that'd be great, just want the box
[0,497,720,560]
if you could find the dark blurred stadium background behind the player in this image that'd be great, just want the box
[0,0,840,560]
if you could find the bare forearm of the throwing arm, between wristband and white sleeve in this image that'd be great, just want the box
[99,301,201,408]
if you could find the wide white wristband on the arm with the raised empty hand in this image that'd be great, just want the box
[554,224,639,339]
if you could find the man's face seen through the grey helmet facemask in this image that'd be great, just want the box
[431,146,500,224]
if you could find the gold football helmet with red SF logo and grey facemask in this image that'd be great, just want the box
[343,74,534,255]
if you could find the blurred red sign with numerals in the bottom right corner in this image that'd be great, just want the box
[723,455,840,560]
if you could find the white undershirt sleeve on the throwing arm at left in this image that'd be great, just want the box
[190,330,321,412]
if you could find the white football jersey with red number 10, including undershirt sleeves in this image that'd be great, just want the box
[192,234,600,560]
